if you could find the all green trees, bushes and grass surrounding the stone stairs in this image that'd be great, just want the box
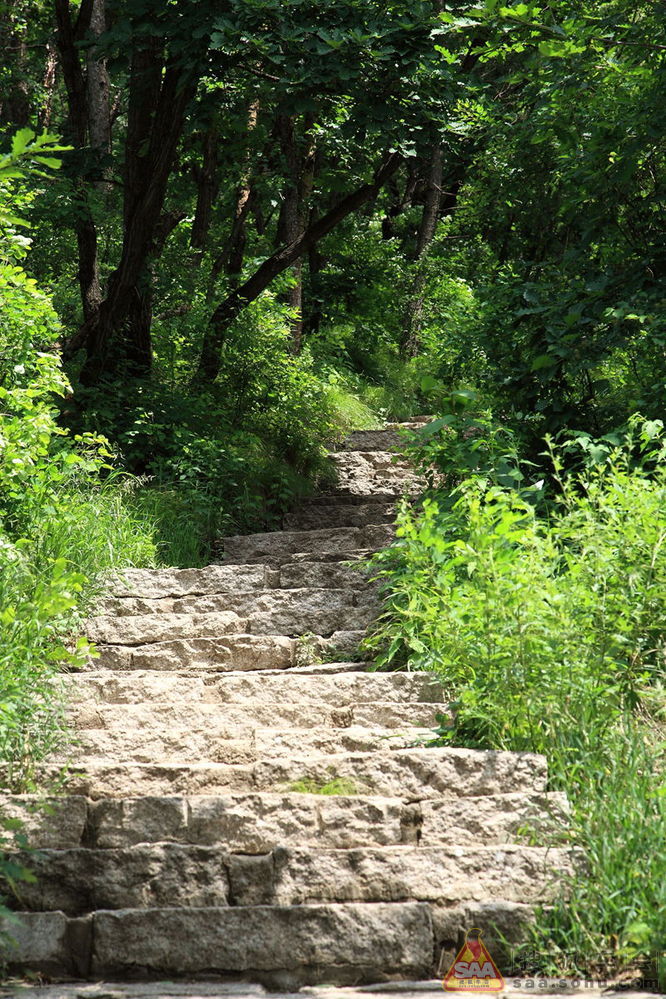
[0,0,666,984]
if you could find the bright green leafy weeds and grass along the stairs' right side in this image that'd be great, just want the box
[369,420,666,986]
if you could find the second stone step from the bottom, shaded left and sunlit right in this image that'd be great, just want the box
[6,843,575,916]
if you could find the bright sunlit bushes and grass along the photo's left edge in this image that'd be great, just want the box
[0,139,154,790]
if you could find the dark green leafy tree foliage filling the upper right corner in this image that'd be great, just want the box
[430,0,666,442]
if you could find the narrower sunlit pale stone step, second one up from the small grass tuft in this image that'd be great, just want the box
[57,702,435,768]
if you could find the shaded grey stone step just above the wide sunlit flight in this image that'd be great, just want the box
[223,524,395,564]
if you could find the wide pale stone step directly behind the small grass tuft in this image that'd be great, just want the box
[20,748,546,800]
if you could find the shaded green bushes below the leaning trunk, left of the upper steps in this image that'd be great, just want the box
[68,296,338,566]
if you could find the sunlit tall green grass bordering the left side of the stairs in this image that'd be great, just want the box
[0,478,157,792]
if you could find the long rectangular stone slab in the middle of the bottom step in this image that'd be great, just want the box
[93,903,433,987]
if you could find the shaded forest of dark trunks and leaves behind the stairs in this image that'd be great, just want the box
[0,0,666,561]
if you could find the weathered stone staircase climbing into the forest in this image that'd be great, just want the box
[0,425,571,989]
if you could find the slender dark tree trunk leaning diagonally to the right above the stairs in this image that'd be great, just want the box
[195,153,401,382]
